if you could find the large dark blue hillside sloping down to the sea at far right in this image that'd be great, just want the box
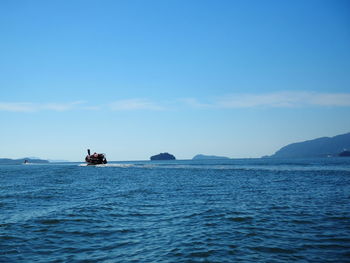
[271,133,350,158]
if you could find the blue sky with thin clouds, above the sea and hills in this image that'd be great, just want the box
[0,0,350,161]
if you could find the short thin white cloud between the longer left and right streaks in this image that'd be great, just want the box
[109,98,164,111]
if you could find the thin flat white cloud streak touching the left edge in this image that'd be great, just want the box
[0,101,84,112]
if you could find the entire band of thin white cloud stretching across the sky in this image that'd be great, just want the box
[0,91,350,112]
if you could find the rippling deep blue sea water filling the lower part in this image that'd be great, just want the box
[0,158,350,263]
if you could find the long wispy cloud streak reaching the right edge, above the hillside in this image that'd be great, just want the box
[182,91,350,109]
